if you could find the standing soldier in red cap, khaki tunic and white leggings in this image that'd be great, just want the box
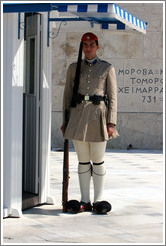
[61,32,118,214]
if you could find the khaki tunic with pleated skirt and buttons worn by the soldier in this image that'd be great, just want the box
[63,58,118,142]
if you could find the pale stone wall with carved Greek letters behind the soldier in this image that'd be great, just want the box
[51,3,163,149]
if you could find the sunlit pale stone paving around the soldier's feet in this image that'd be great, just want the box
[3,150,165,245]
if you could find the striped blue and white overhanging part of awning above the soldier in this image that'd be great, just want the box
[58,3,146,34]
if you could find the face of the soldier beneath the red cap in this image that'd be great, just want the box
[82,40,99,60]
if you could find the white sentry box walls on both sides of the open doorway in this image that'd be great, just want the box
[3,13,54,217]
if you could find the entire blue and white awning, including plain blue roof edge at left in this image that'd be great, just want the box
[3,1,146,34]
